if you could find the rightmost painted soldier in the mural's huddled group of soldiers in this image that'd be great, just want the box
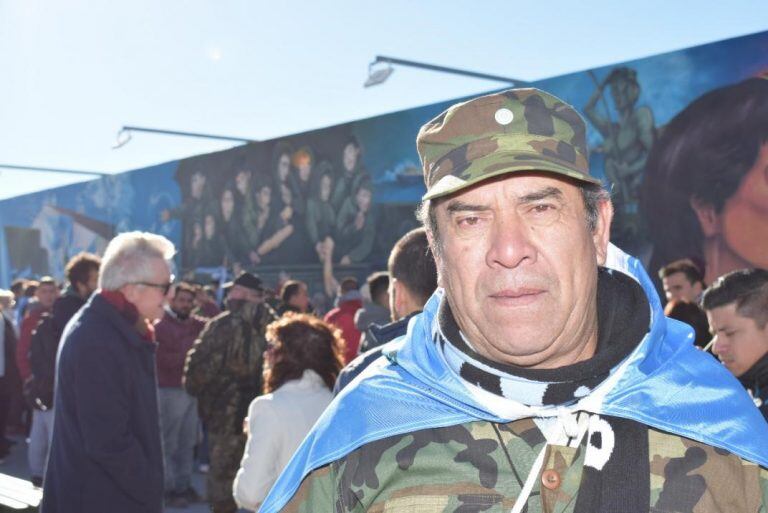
[336,180,376,265]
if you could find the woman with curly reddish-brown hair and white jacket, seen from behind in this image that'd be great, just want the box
[233,312,343,511]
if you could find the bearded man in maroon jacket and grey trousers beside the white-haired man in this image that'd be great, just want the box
[155,283,205,507]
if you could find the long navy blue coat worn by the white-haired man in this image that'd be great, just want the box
[41,294,163,513]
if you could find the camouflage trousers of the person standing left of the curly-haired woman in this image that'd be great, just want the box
[207,434,246,513]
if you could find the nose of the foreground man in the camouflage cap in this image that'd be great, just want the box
[486,215,536,269]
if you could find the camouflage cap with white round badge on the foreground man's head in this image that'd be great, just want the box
[416,88,600,200]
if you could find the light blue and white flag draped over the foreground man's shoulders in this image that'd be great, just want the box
[259,245,768,513]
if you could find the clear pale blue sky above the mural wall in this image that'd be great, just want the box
[0,0,768,198]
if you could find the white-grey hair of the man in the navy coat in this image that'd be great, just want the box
[99,231,176,290]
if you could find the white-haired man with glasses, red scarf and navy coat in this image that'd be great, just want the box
[42,232,175,513]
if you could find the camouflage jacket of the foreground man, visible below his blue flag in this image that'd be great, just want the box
[283,419,768,513]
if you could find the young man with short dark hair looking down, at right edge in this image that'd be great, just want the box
[702,269,768,420]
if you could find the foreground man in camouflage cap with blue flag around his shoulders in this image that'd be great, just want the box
[260,89,768,513]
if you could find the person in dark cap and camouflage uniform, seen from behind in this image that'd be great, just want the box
[184,272,276,513]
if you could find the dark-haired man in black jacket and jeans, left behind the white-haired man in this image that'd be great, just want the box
[27,252,101,486]
